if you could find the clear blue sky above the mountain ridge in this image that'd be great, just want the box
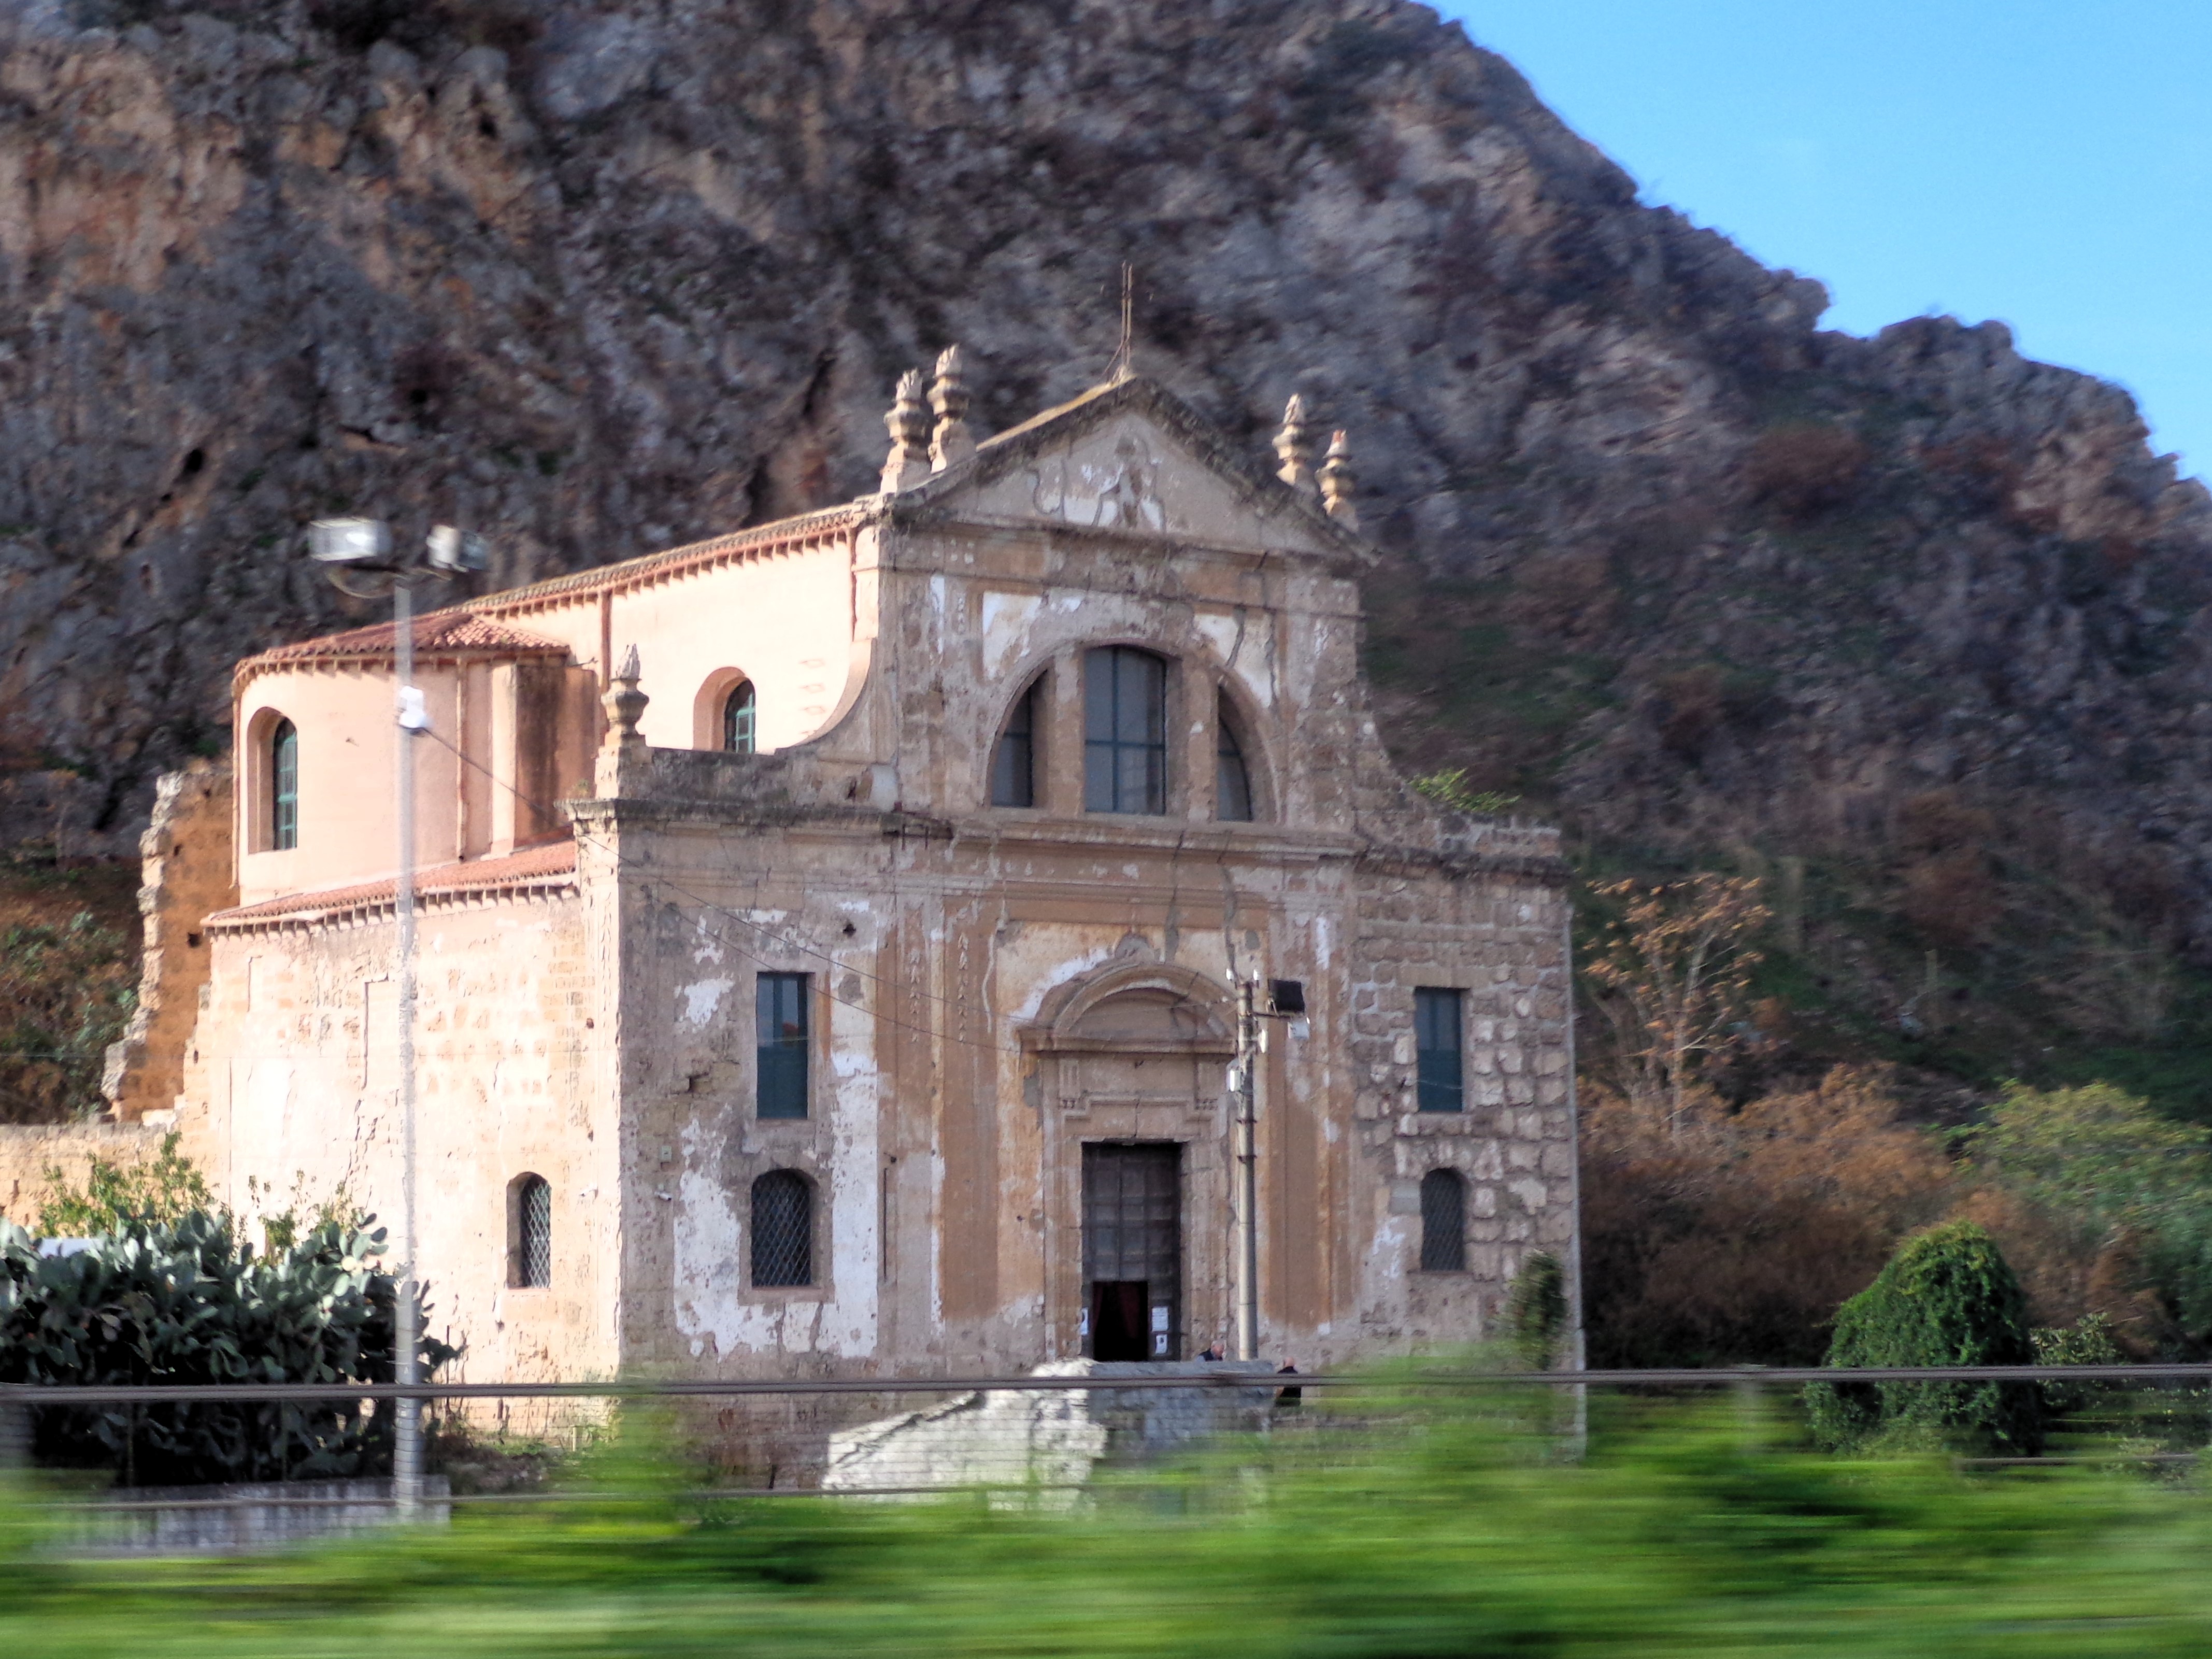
[1440,0,2212,478]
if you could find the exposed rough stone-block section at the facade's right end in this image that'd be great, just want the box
[1338,858,1575,1347]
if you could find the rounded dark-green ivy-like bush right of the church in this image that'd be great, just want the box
[1805,1221,2044,1455]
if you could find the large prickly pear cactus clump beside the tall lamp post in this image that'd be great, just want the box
[0,1210,455,1484]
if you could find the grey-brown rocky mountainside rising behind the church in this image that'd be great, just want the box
[13,0,2212,1097]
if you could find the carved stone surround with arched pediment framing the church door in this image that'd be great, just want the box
[1020,962,1265,1360]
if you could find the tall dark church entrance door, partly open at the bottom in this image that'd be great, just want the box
[1084,1141,1183,1360]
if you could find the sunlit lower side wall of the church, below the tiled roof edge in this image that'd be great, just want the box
[179,891,619,1380]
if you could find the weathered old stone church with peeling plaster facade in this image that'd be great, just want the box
[110,354,1577,1380]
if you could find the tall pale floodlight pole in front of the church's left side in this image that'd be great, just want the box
[307,518,484,1520]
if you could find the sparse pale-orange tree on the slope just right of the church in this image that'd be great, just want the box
[1581,872,1769,1132]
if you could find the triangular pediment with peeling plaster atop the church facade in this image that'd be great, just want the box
[898,380,1365,560]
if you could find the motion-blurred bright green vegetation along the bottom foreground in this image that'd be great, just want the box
[0,1389,2212,1659]
